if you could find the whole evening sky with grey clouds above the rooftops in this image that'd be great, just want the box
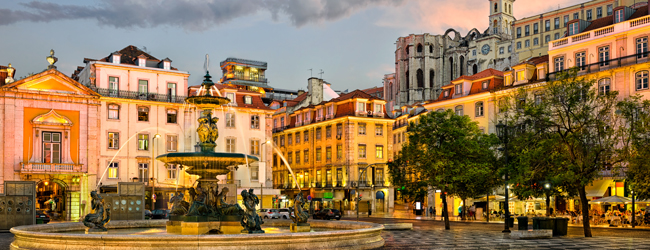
[0,0,586,91]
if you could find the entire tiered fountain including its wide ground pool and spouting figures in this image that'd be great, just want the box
[11,67,384,250]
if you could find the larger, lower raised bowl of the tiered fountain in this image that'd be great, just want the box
[156,152,259,179]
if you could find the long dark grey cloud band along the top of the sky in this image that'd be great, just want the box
[0,0,404,30]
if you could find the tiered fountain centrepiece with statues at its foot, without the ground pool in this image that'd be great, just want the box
[156,72,264,235]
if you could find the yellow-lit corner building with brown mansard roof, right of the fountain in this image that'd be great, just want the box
[273,90,394,213]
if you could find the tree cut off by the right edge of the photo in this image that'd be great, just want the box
[618,96,650,200]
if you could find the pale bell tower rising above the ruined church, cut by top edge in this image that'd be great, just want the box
[488,0,515,36]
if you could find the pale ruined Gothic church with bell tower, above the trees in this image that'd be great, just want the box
[384,0,518,111]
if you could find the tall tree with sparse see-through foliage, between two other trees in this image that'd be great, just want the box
[502,68,620,237]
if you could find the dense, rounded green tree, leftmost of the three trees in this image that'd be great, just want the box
[389,110,499,229]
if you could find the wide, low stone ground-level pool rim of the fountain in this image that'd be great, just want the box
[11,220,384,250]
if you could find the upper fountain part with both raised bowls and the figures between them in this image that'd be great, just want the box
[156,72,259,179]
